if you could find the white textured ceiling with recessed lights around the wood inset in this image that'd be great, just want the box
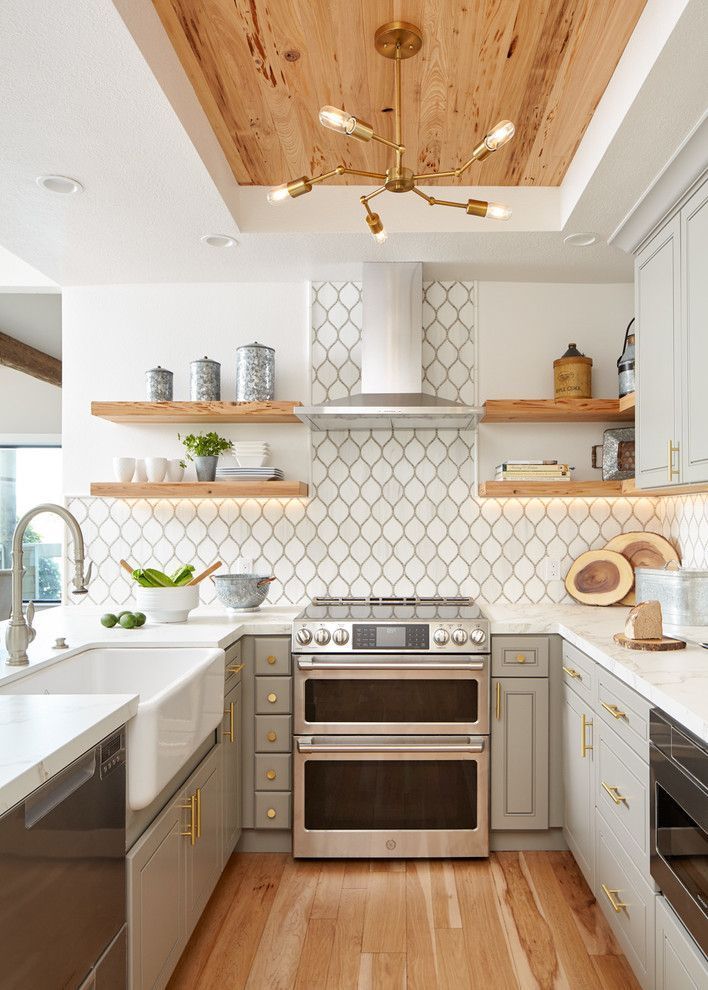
[0,0,706,285]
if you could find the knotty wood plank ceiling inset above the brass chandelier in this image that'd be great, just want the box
[153,0,646,186]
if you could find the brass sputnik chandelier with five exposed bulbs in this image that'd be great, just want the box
[268,21,514,244]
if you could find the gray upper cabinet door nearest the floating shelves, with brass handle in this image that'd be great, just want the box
[635,215,681,488]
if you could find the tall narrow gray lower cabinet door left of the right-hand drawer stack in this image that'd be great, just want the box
[562,685,595,889]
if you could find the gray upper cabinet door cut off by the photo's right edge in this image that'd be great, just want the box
[680,182,708,484]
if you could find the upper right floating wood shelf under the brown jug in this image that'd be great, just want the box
[481,396,634,423]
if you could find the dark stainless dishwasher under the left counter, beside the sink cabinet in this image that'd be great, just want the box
[0,729,127,990]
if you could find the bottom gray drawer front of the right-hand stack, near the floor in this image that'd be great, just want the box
[595,812,655,987]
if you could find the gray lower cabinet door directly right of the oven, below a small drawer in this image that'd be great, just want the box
[491,677,548,829]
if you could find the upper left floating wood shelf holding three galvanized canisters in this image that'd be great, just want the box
[91,401,302,423]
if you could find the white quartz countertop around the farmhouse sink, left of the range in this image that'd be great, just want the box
[0,605,300,814]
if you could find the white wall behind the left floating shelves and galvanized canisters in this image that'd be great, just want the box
[63,282,309,494]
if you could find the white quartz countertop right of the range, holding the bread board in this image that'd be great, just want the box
[478,602,708,743]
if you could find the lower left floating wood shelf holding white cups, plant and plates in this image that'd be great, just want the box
[91,481,308,498]
